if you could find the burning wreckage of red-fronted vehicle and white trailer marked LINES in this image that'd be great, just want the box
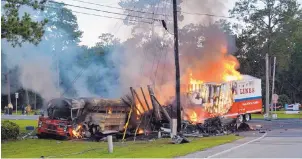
[37,76,262,141]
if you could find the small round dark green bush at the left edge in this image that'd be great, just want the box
[1,120,20,140]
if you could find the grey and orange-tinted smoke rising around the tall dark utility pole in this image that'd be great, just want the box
[113,0,239,102]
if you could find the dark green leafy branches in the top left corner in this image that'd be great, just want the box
[1,0,47,47]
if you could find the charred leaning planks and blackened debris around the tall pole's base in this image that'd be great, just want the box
[116,86,251,143]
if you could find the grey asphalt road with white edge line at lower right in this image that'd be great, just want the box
[181,119,302,158]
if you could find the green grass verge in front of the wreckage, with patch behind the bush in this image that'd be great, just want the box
[1,120,241,158]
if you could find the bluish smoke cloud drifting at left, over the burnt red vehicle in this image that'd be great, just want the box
[1,4,116,101]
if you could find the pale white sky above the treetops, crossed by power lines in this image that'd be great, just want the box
[57,0,302,46]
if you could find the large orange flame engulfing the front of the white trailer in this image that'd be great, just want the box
[185,47,242,123]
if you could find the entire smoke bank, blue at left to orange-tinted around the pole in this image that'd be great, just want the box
[1,0,236,106]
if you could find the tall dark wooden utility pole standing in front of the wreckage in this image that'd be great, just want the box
[173,0,181,133]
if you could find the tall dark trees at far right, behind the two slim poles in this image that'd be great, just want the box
[230,0,302,101]
